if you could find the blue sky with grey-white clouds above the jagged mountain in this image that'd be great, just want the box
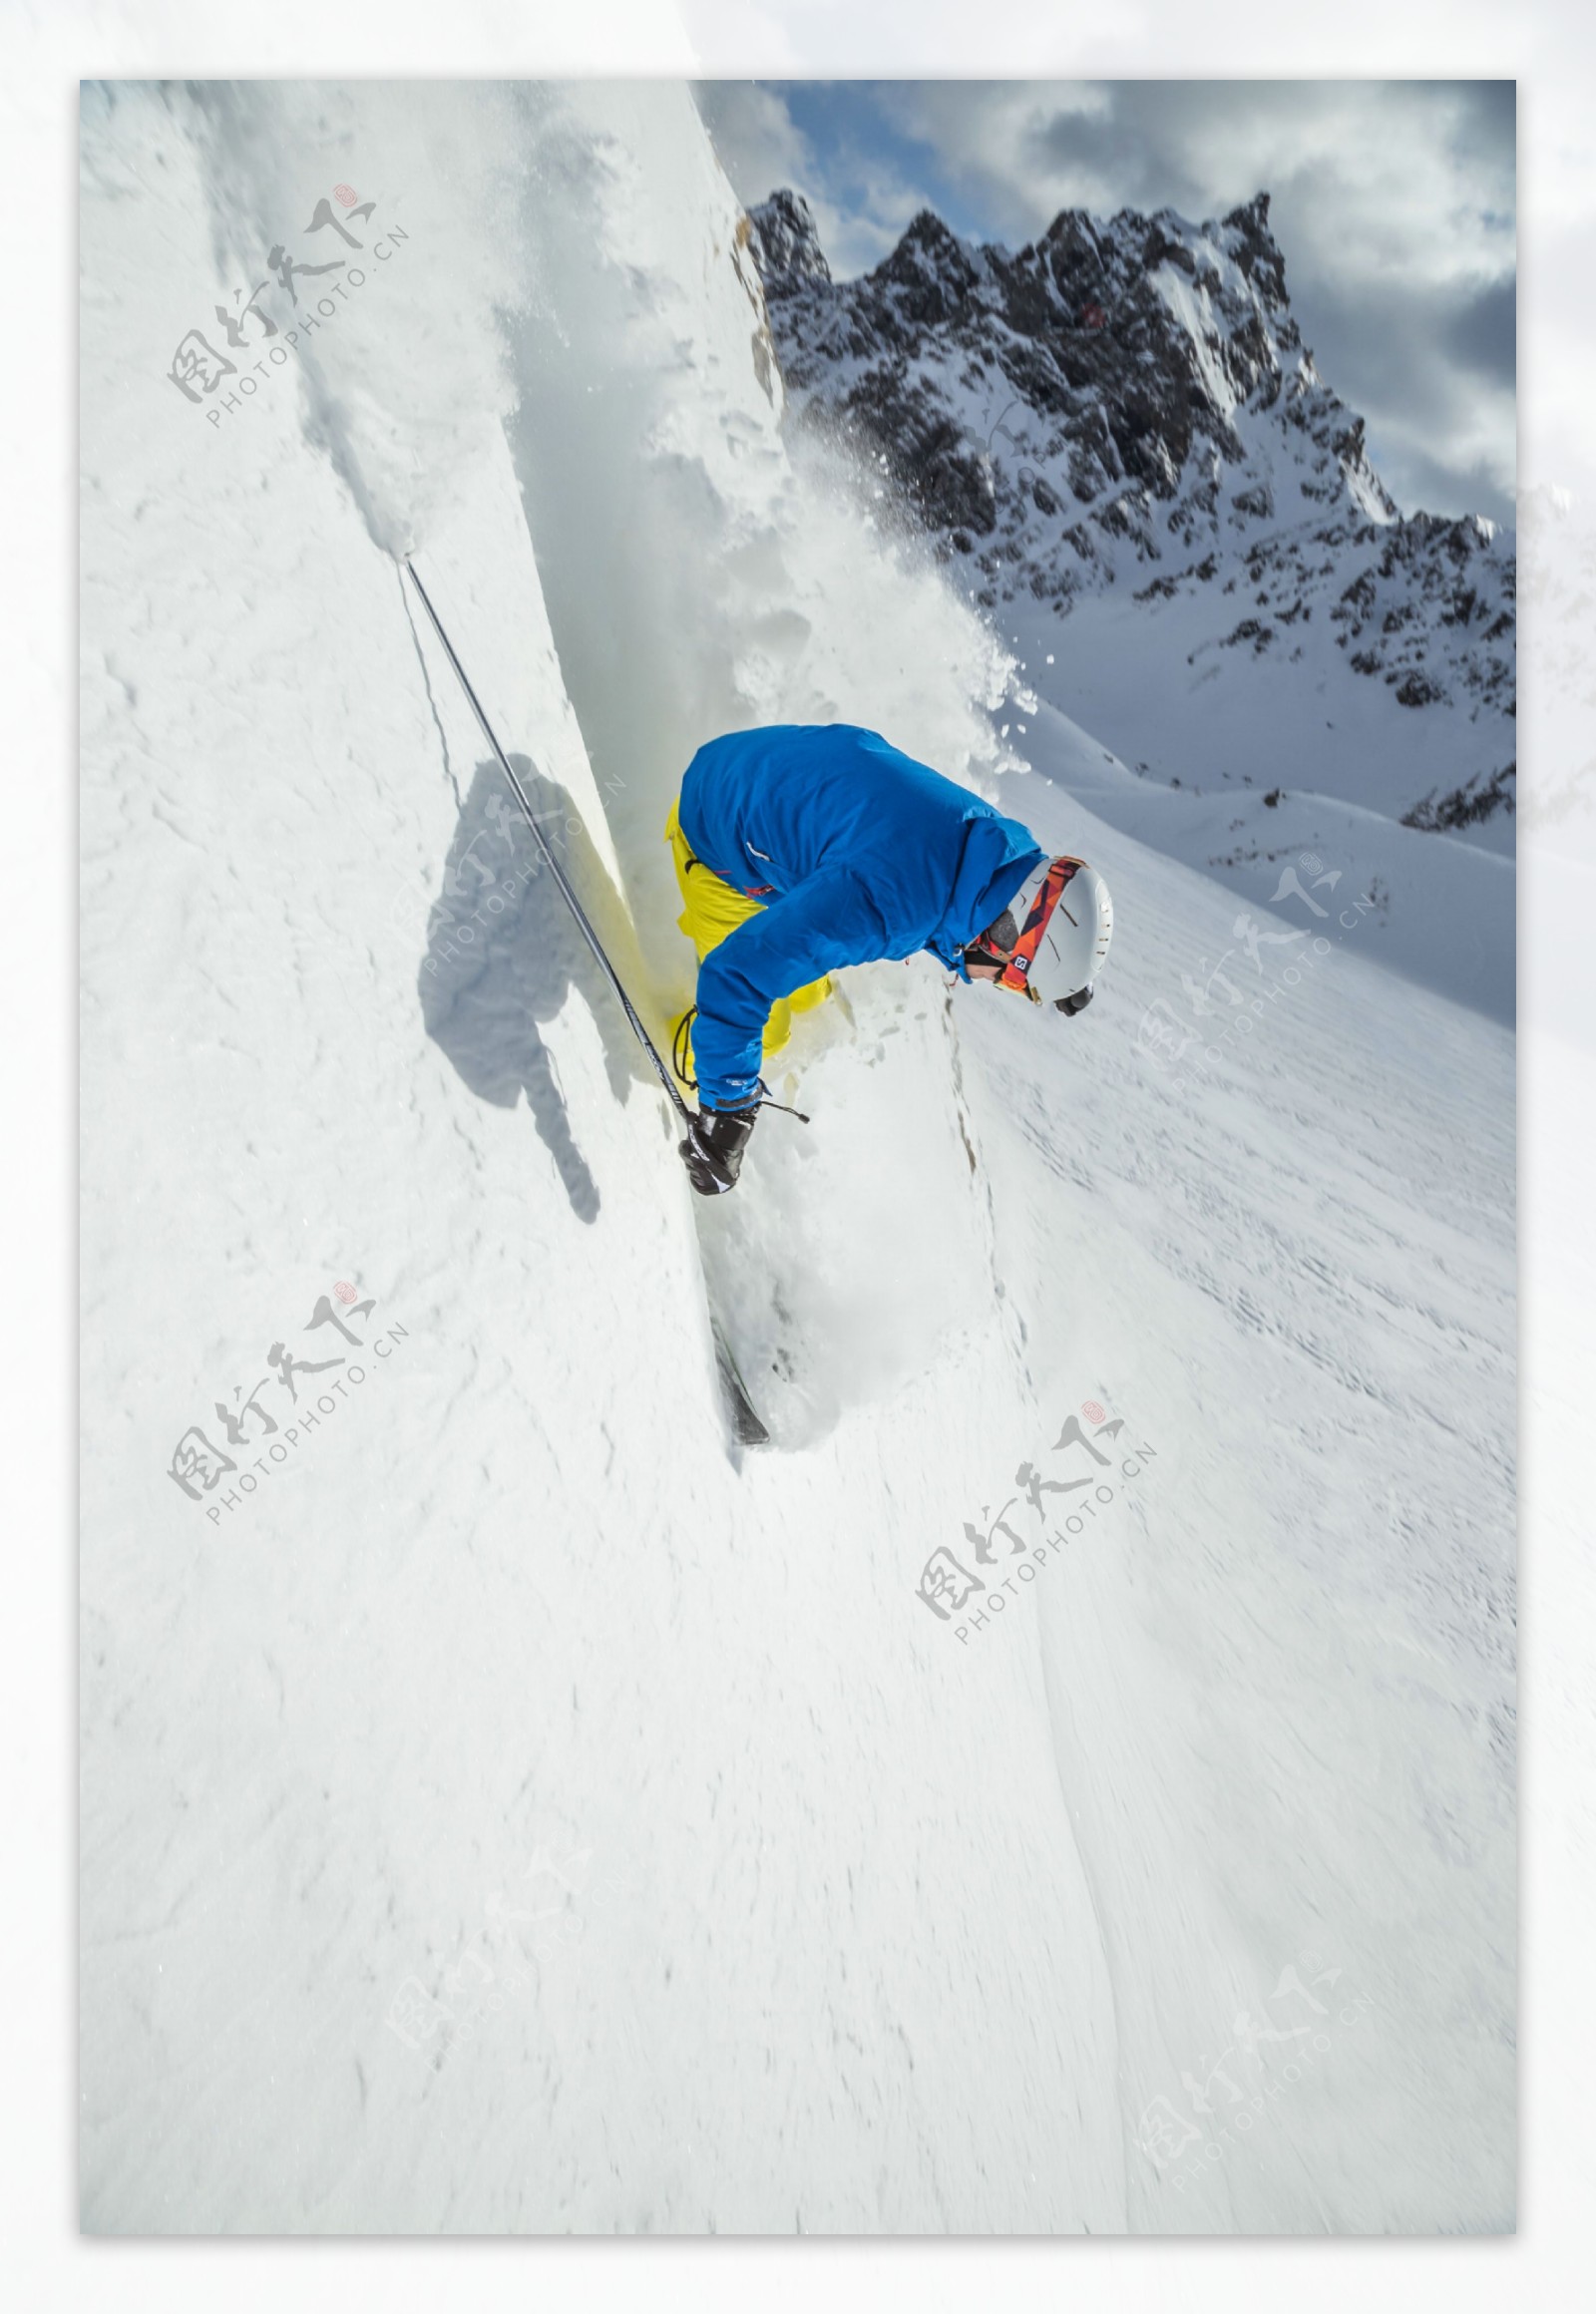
[696,81,1517,521]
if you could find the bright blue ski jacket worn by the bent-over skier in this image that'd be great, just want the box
[677,724,1047,1108]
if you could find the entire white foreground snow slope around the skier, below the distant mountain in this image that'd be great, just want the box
[81,86,1513,2233]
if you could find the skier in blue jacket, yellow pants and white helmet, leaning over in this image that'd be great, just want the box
[666,724,1112,1196]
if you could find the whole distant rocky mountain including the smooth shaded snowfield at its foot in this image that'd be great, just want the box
[752,193,1515,842]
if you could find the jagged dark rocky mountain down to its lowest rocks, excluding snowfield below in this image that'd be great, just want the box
[752,193,1515,833]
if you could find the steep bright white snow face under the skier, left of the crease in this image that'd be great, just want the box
[81,88,1126,2233]
